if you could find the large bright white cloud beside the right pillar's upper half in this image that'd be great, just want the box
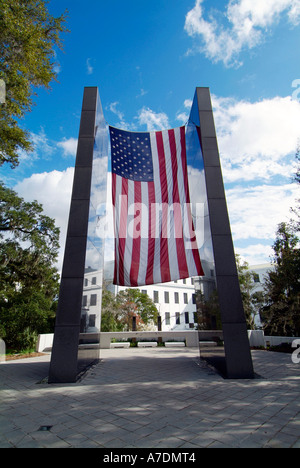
[212,96,300,182]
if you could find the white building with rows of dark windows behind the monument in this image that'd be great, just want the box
[81,261,272,333]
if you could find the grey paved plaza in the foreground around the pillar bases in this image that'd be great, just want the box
[0,348,300,449]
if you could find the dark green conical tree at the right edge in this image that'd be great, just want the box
[262,223,300,336]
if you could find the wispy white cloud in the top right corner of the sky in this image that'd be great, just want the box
[185,0,300,66]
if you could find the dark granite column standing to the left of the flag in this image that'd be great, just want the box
[49,88,102,383]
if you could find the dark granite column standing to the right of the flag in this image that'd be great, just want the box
[191,88,254,379]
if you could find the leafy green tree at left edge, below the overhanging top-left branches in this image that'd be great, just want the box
[0,183,59,350]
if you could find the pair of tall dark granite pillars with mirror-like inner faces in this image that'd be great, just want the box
[49,87,254,383]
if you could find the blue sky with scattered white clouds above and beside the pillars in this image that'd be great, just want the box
[0,0,300,264]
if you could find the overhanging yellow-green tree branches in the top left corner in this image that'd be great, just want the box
[0,0,67,167]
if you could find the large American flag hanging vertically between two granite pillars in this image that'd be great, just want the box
[109,127,204,287]
